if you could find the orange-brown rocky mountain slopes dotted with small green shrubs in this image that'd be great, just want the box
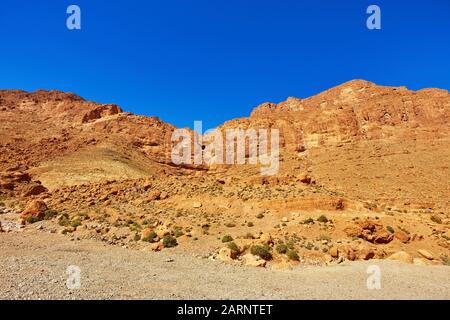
[0,80,450,298]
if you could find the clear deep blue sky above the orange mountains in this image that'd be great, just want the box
[0,0,450,129]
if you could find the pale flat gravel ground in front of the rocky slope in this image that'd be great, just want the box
[0,230,450,299]
